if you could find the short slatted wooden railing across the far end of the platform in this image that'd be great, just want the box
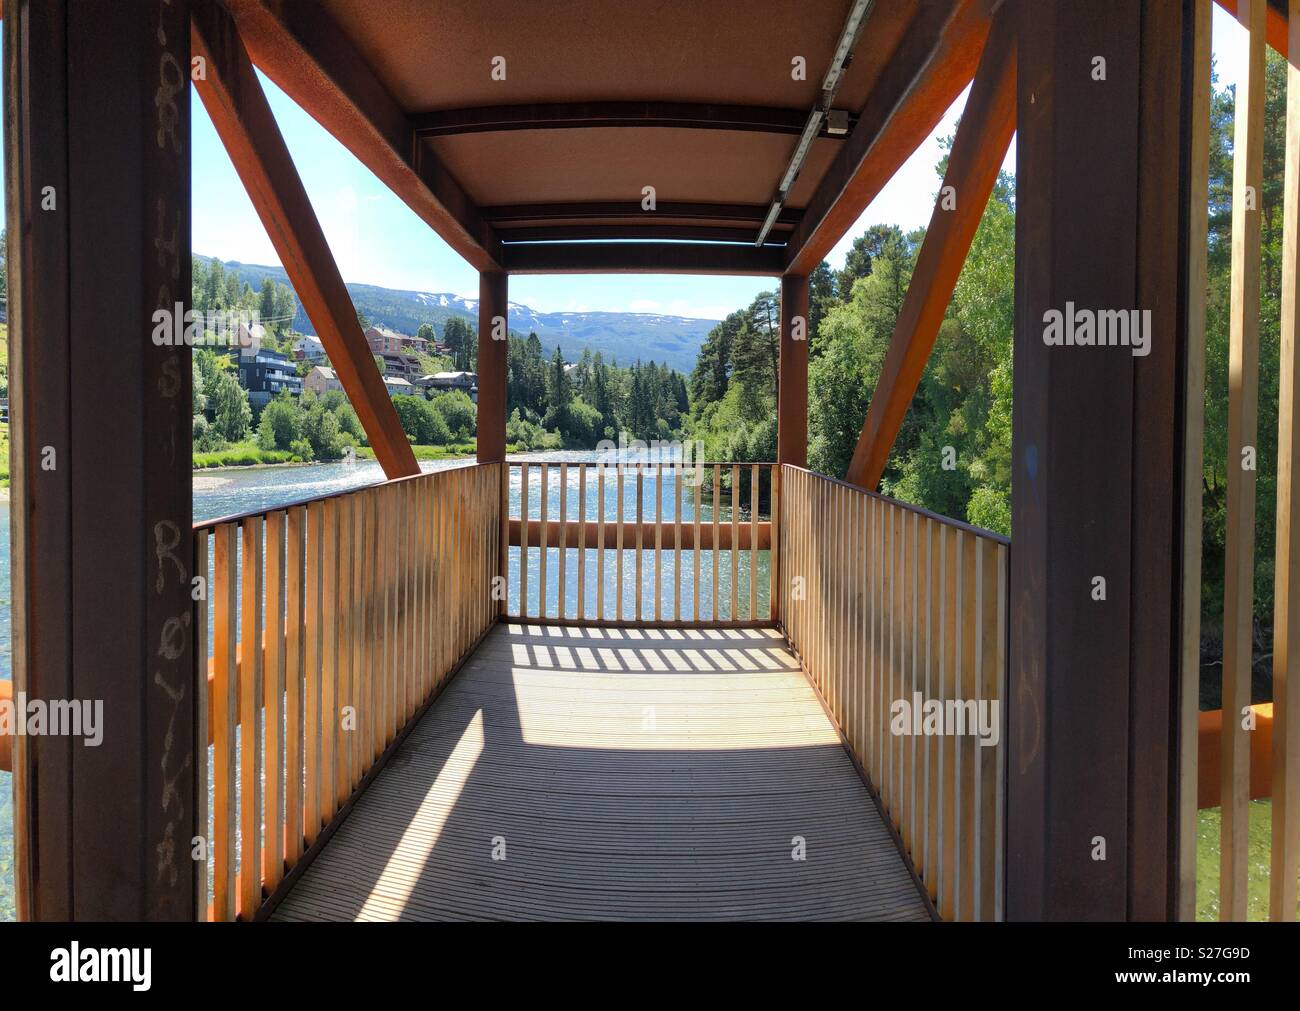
[506,463,780,625]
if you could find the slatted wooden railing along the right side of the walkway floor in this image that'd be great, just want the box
[779,467,1009,920]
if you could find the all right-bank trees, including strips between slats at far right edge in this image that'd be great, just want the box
[685,49,1287,708]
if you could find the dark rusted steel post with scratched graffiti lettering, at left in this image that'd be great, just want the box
[4,0,199,920]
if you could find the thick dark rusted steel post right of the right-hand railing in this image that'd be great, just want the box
[1005,0,1199,920]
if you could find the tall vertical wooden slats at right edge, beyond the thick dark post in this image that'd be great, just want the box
[1178,0,1300,920]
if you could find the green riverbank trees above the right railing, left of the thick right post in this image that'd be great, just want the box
[686,148,1015,534]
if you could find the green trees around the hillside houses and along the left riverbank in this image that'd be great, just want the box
[192,257,689,465]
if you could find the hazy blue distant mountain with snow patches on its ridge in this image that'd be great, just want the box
[200,257,718,373]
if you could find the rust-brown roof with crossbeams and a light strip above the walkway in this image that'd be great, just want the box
[226,0,996,274]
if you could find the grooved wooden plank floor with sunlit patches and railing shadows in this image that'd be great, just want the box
[276,624,928,920]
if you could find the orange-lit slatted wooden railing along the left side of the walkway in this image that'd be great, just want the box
[194,465,501,920]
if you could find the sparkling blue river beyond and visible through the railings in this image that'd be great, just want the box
[0,452,768,920]
